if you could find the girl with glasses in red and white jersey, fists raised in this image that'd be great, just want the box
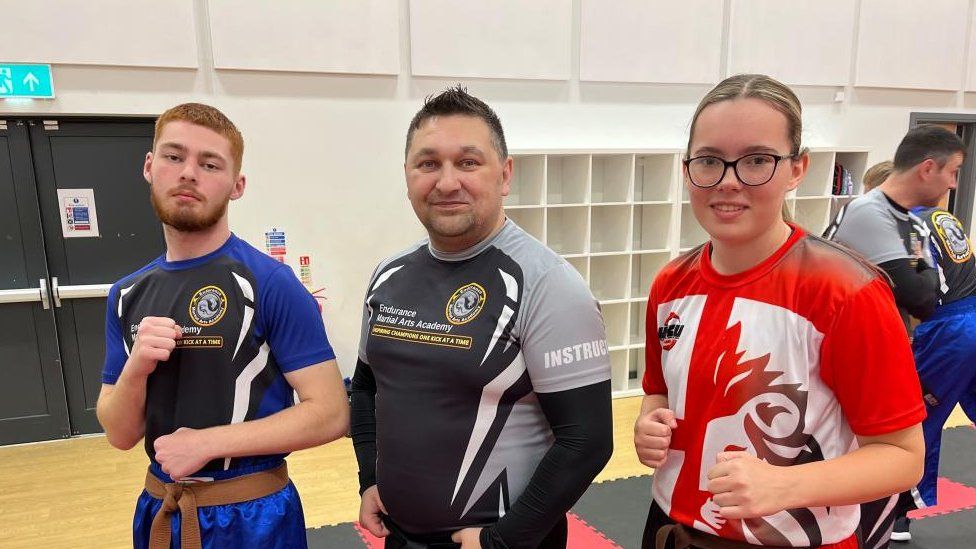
[634,75,925,549]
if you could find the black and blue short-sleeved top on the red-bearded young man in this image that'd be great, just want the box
[102,235,335,479]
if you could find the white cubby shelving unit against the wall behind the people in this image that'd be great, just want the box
[505,148,868,397]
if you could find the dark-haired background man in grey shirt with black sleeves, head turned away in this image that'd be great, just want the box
[824,126,968,549]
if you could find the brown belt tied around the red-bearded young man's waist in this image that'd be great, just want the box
[146,463,288,549]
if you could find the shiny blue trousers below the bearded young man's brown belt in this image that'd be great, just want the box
[132,460,308,549]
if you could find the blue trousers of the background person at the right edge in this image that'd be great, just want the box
[912,297,976,507]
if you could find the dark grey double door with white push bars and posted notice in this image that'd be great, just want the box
[0,115,164,444]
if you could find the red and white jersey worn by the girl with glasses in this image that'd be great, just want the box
[644,227,925,547]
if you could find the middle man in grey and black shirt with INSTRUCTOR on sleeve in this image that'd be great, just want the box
[352,88,612,549]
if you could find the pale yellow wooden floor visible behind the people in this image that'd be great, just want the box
[0,397,968,549]
